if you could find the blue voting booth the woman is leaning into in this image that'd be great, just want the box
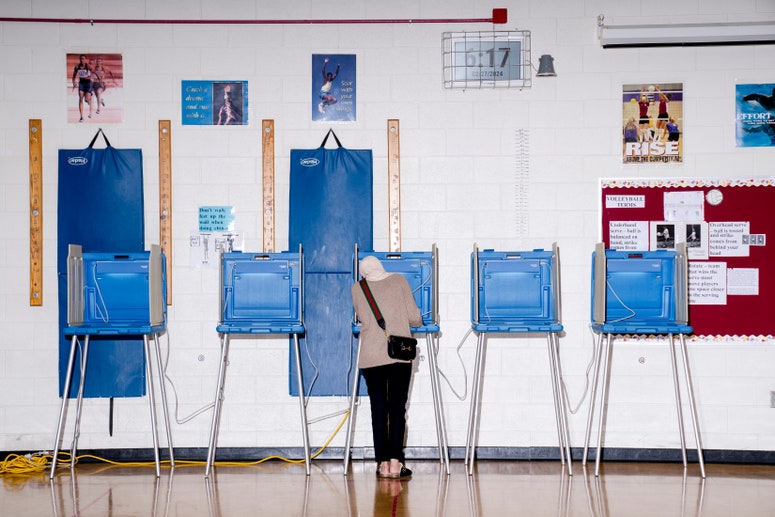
[344,244,449,475]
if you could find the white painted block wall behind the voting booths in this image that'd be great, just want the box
[0,0,775,458]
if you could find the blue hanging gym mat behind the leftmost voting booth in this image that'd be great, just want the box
[57,137,145,397]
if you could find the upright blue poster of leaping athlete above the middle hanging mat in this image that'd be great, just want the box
[312,54,357,122]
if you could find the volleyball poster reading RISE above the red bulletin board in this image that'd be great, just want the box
[622,83,683,163]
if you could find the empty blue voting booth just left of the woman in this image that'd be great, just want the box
[205,246,310,476]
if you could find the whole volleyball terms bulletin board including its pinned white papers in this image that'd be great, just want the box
[600,177,775,339]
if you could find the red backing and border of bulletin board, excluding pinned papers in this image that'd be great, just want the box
[600,178,775,337]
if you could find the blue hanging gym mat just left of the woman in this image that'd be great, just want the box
[288,130,374,396]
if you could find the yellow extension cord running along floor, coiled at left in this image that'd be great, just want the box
[0,409,350,475]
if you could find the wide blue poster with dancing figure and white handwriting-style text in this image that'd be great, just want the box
[180,81,248,126]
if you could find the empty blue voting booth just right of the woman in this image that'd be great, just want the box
[465,244,572,475]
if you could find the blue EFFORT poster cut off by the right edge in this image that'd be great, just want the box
[735,84,775,147]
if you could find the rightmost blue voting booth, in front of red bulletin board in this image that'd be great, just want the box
[583,243,705,478]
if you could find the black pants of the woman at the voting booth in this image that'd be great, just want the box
[361,363,412,463]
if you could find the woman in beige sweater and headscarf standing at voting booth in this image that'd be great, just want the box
[352,256,422,479]
